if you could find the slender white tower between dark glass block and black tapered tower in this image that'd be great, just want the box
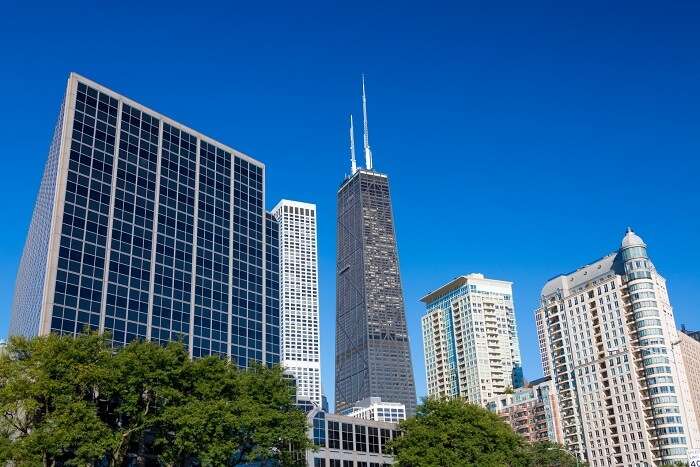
[272,199,321,407]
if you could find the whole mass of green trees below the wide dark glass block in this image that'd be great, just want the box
[0,334,309,466]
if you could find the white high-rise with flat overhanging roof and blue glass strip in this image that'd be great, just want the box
[421,274,521,404]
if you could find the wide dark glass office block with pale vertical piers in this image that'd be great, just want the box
[10,73,279,367]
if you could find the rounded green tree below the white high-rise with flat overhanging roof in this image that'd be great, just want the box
[390,398,530,467]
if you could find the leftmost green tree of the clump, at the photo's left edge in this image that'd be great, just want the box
[0,335,117,465]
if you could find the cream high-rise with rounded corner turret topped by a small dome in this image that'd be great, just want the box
[535,230,700,467]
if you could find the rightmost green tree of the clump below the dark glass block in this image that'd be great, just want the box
[159,357,310,465]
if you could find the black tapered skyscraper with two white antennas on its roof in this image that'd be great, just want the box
[335,79,416,416]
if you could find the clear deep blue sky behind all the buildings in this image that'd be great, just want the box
[0,0,700,401]
